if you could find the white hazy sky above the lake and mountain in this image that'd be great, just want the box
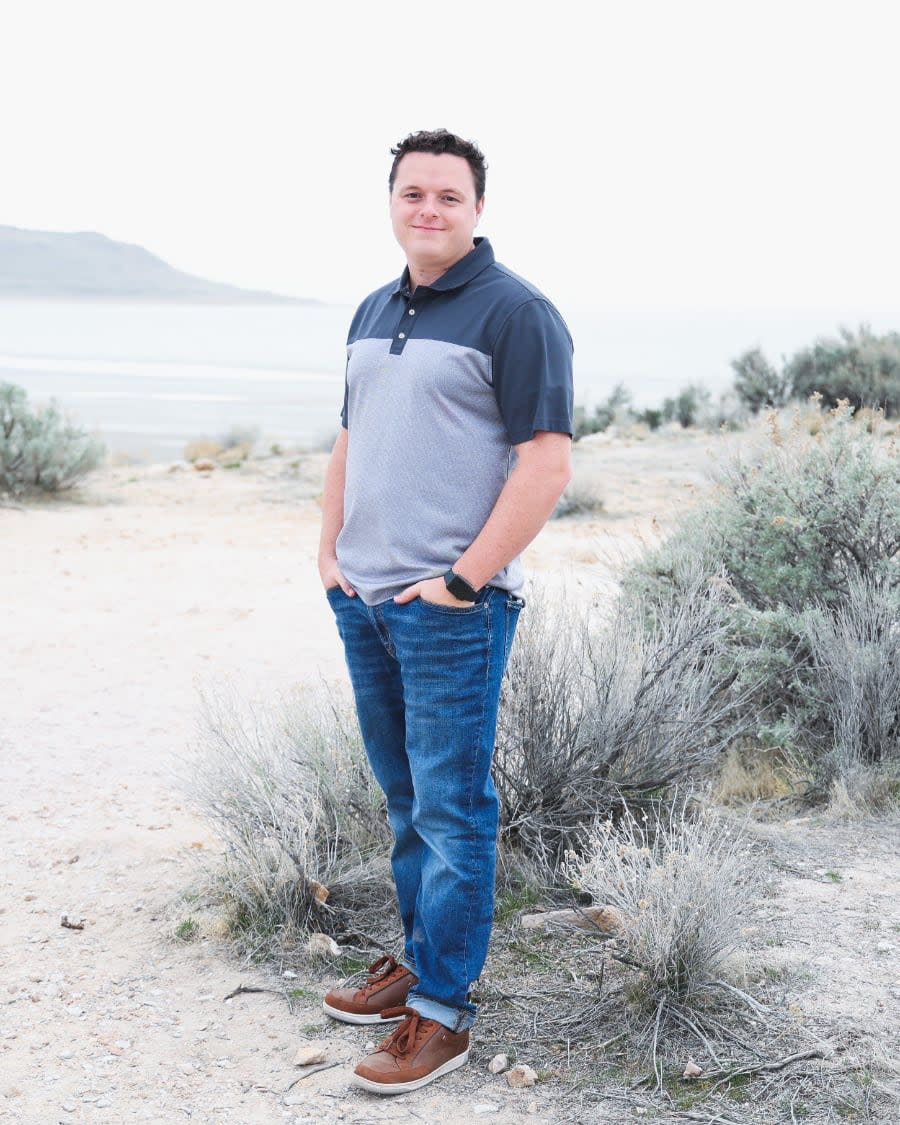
[0,0,900,311]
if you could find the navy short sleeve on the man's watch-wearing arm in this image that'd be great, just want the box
[492,297,575,446]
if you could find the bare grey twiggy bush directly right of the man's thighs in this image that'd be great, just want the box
[494,567,738,872]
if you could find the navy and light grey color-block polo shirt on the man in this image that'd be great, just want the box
[336,239,574,605]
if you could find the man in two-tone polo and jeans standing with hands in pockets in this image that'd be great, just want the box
[318,129,573,1094]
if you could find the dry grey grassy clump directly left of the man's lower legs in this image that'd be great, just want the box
[182,689,394,959]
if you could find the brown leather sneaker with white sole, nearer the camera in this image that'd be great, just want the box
[353,1008,469,1094]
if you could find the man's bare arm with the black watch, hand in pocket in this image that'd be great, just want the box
[394,430,572,605]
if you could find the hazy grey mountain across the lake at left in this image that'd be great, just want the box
[0,226,309,305]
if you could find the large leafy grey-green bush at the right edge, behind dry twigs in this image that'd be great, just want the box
[627,405,900,780]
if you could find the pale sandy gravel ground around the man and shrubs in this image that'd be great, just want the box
[0,437,900,1125]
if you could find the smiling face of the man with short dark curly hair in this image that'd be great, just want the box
[390,152,484,277]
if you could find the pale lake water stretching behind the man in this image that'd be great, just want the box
[0,300,900,460]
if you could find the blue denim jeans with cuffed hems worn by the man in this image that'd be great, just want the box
[327,586,524,1031]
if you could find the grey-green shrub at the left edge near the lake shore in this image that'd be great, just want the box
[0,383,105,495]
